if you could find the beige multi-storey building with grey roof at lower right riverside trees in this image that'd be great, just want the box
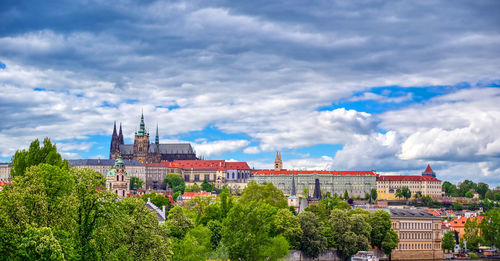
[389,209,443,260]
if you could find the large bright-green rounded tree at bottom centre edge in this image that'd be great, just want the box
[222,201,288,260]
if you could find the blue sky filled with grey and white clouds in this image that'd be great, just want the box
[0,0,500,186]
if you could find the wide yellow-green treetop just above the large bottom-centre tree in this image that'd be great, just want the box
[240,180,288,208]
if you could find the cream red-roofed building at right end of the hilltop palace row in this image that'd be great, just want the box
[377,175,442,200]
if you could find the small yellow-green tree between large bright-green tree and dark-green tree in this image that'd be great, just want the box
[274,208,302,248]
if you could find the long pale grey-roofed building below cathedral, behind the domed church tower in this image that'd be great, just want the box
[68,159,146,182]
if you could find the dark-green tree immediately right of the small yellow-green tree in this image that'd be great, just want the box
[298,211,327,258]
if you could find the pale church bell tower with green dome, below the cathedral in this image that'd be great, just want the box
[106,156,130,199]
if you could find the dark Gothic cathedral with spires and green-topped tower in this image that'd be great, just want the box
[109,114,198,163]
